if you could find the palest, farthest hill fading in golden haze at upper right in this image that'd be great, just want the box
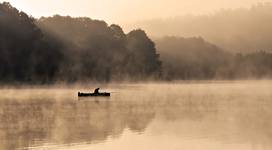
[126,3,272,53]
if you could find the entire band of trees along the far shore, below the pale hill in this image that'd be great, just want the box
[0,2,272,83]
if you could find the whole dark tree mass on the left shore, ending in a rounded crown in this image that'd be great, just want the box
[0,2,161,83]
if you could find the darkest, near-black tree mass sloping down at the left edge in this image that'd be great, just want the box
[0,2,61,82]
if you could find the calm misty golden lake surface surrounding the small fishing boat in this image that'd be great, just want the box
[0,81,272,150]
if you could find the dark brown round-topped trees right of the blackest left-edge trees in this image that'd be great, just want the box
[37,15,163,81]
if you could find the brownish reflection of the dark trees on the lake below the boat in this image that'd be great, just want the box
[0,96,155,149]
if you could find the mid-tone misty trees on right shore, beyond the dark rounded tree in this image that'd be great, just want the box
[156,37,272,80]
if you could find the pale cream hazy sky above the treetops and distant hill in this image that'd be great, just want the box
[0,0,272,23]
